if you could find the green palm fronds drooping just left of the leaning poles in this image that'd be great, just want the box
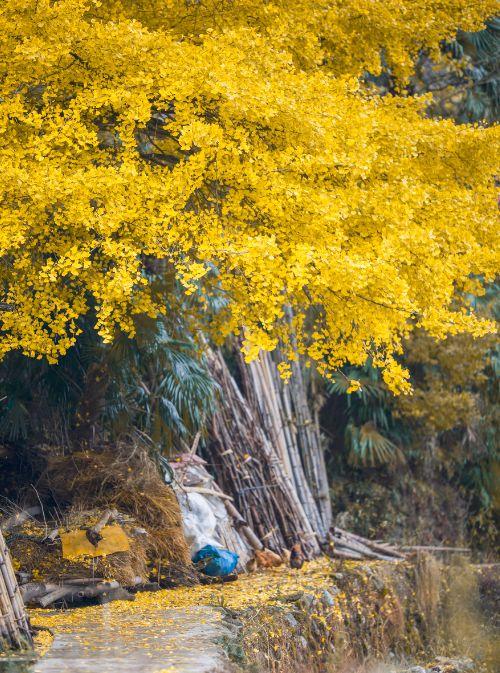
[104,320,217,450]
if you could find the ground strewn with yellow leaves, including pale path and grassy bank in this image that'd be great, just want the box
[32,556,498,673]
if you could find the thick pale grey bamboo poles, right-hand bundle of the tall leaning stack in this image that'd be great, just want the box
[240,353,332,538]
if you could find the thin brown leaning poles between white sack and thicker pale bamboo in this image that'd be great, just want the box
[207,351,319,554]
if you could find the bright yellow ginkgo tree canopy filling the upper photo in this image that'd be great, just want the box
[0,0,498,391]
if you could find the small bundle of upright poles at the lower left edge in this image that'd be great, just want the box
[0,531,33,651]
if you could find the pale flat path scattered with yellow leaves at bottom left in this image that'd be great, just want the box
[32,604,224,673]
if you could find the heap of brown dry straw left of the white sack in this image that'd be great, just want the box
[39,449,192,577]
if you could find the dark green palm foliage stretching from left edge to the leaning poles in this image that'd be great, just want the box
[0,317,217,453]
